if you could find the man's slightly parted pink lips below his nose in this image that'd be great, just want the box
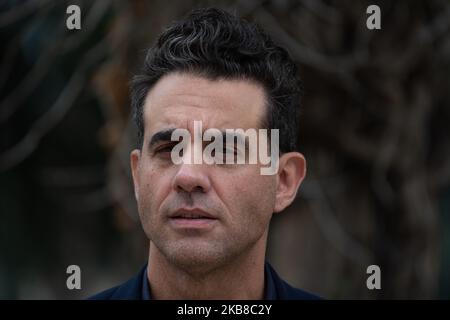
[169,208,218,229]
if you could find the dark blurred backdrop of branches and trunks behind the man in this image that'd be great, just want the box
[0,0,450,299]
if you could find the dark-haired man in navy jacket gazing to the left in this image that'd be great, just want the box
[93,9,316,299]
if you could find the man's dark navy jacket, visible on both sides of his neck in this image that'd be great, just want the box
[89,263,320,300]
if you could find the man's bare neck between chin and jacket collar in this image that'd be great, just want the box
[147,233,267,300]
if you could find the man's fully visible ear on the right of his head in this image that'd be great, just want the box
[274,152,306,212]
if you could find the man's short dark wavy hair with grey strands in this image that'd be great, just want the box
[131,8,302,153]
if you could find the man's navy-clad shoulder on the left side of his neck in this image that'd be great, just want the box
[88,266,146,300]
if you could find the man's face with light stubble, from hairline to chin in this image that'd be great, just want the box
[131,74,277,268]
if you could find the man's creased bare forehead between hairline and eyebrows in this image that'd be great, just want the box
[144,73,266,136]
